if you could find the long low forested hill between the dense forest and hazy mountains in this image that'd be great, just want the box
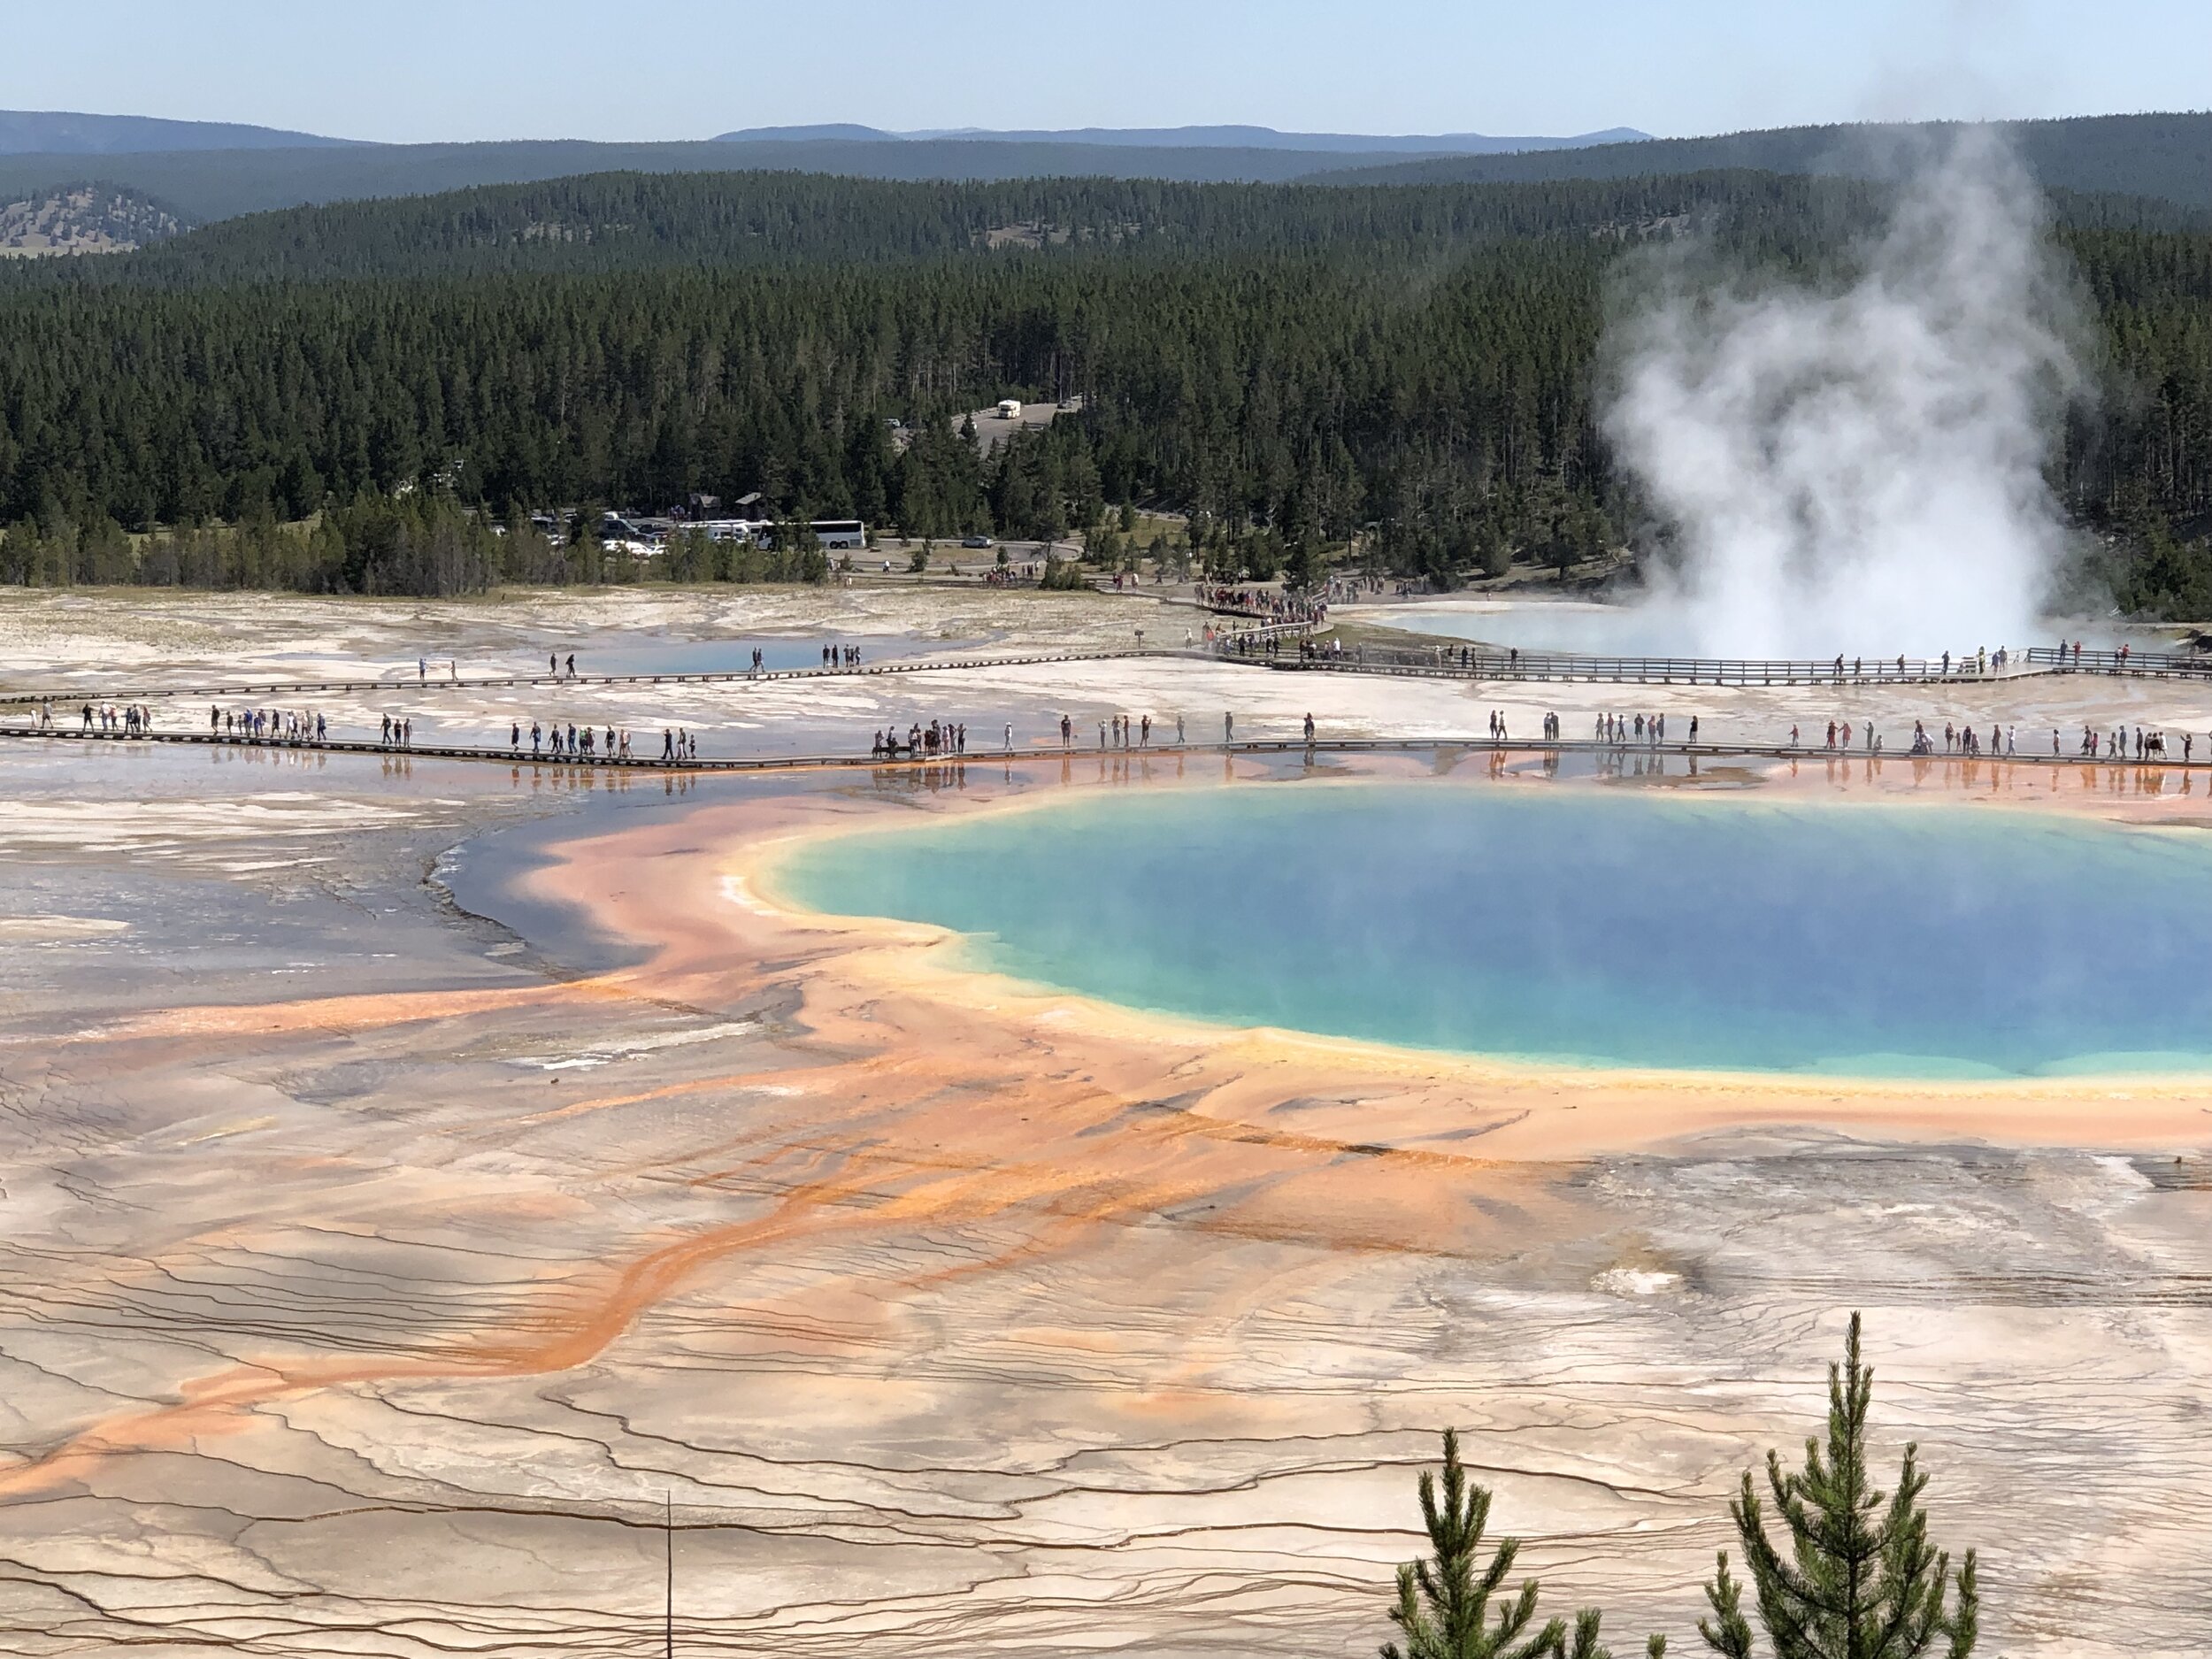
[35,173,2212,288]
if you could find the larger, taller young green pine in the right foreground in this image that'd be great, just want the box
[1697,1314,1980,1659]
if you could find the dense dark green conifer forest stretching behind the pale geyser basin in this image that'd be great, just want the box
[0,166,2212,618]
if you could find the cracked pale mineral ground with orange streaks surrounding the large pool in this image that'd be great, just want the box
[0,595,2212,1659]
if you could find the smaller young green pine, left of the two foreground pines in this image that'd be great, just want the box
[1383,1429,1666,1659]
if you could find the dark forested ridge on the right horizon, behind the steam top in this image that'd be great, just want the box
[1312,113,2212,208]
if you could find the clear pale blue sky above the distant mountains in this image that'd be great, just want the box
[0,0,2212,142]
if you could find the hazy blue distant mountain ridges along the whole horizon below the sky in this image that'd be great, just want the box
[0,113,2212,224]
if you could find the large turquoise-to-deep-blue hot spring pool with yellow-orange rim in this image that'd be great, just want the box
[781,783,2212,1078]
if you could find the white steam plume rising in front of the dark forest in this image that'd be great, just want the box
[1606,128,2084,657]
